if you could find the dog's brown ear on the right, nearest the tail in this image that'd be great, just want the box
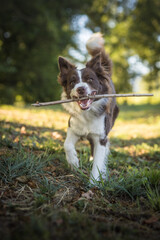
[86,53,102,73]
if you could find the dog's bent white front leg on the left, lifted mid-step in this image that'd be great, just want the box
[64,127,79,168]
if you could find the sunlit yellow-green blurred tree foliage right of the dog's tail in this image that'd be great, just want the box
[85,0,160,92]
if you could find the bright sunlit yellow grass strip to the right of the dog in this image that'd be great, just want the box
[111,105,160,139]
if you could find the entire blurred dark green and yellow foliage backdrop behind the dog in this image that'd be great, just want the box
[0,0,160,103]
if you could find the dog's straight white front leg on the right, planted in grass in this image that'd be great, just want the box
[90,136,109,184]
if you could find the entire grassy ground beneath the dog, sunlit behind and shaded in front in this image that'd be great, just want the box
[0,104,160,240]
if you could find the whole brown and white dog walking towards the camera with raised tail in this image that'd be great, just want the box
[58,33,119,183]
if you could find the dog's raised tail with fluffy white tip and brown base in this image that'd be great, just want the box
[86,32,112,76]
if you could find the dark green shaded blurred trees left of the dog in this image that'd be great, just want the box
[0,0,91,103]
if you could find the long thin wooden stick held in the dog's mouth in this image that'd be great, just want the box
[32,93,153,107]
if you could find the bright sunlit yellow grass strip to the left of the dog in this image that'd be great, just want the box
[0,106,68,130]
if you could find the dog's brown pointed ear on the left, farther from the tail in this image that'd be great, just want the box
[58,57,76,87]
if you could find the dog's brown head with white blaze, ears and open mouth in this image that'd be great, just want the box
[58,54,108,110]
